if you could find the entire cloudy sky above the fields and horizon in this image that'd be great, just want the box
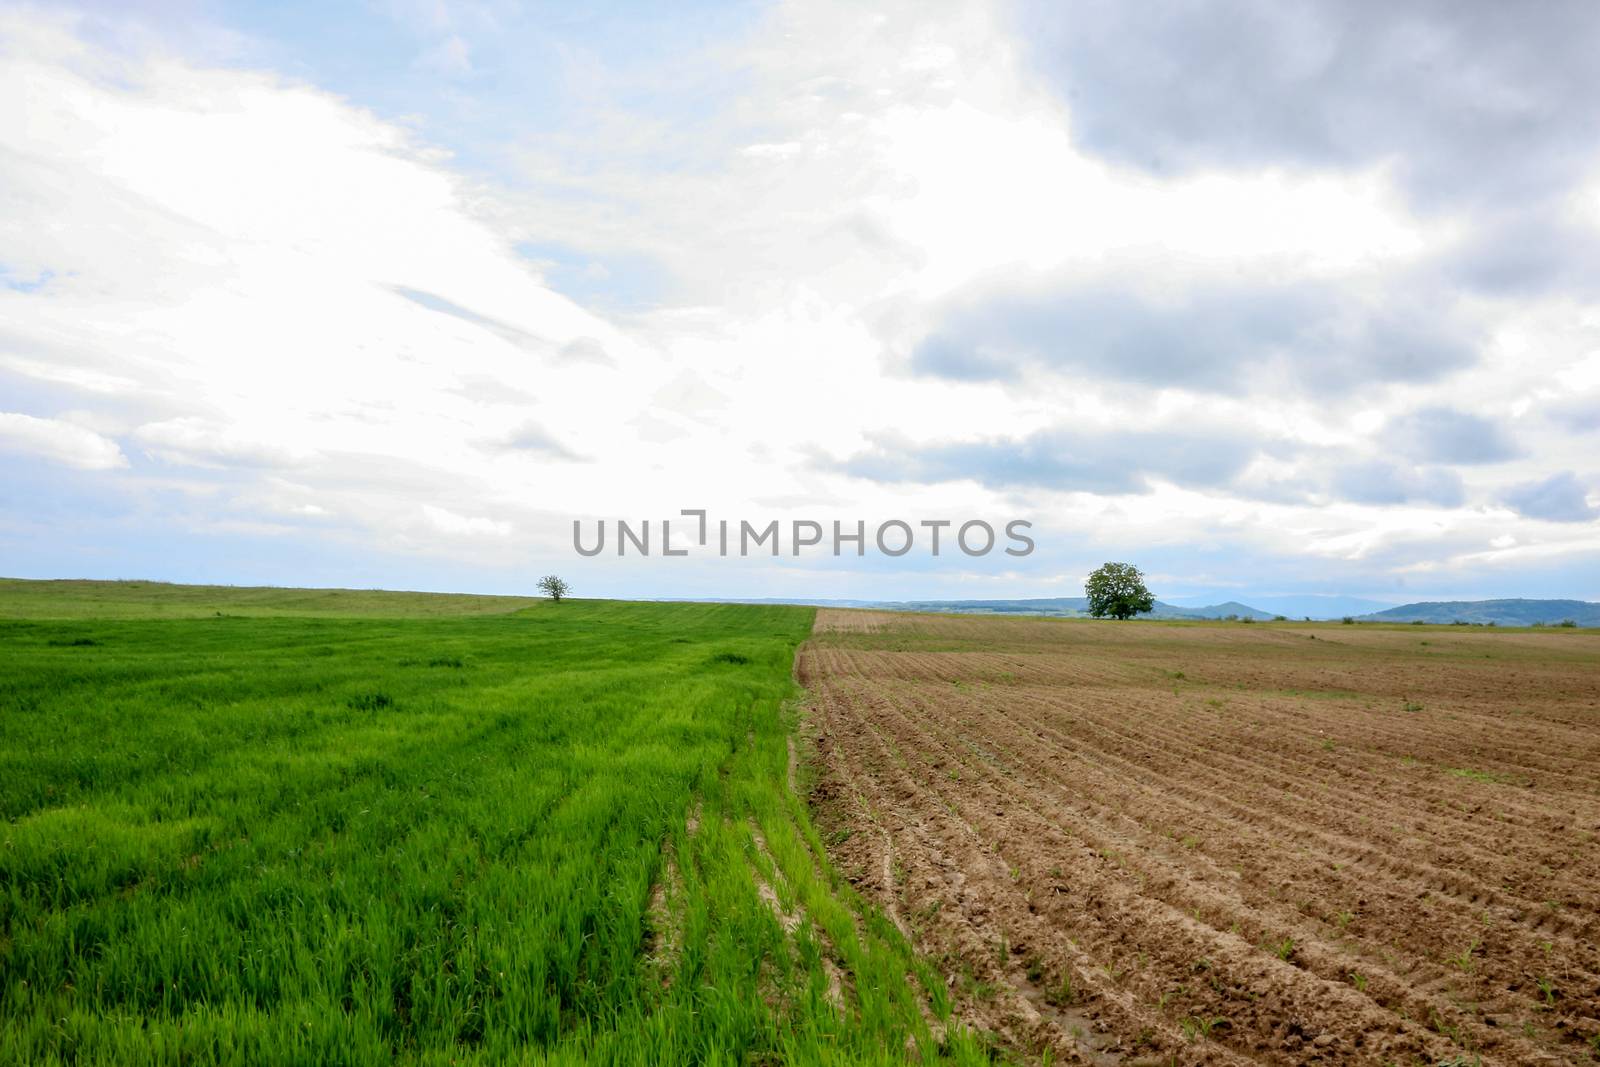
[0,0,1600,603]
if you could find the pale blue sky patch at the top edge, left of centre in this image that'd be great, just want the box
[208,0,771,182]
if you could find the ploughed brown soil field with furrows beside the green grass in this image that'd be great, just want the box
[798,609,1600,1064]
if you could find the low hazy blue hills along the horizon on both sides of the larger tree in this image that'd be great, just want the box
[678,597,1600,627]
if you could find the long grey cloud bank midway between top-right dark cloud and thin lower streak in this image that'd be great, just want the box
[910,275,1475,394]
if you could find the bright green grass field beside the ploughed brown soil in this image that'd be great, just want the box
[0,582,987,1064]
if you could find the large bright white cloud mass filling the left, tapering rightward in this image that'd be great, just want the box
[0,11,675,522]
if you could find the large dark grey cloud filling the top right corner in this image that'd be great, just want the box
[1016,0,1600,294]
